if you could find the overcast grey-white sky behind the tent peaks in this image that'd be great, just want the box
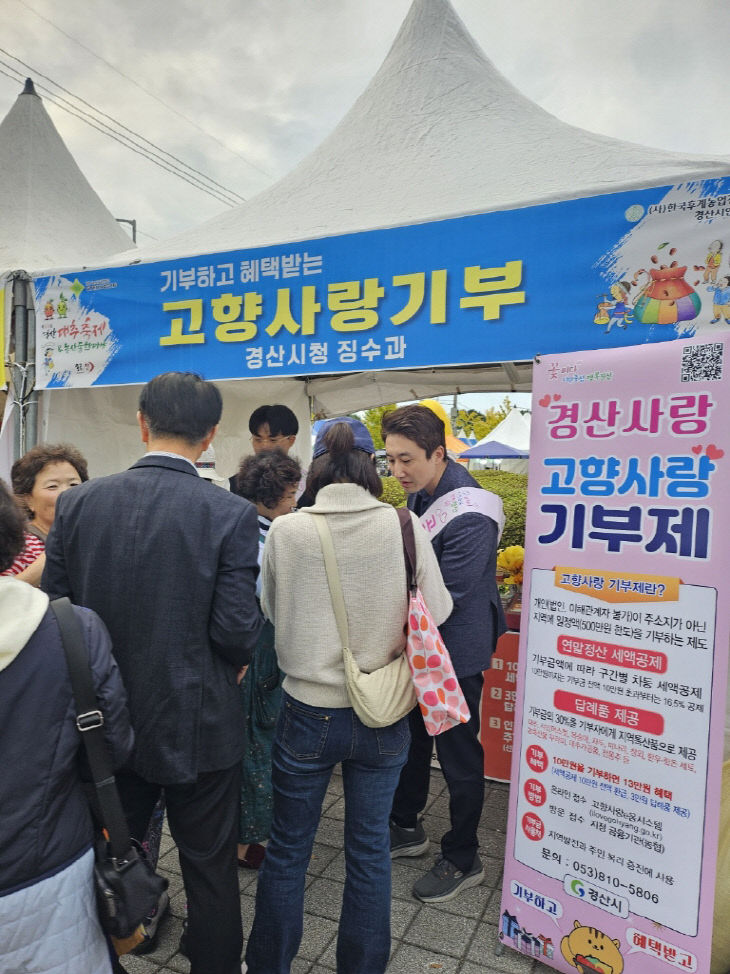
[0,0,730,252]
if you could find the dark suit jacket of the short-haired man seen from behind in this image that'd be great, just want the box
[42,454,262,784]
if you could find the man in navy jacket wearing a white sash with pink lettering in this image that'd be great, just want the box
[382,406,506,903]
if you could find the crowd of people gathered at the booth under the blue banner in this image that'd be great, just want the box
[0,373,504,974]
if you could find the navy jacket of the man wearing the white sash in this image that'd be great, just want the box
[408,460,507,676]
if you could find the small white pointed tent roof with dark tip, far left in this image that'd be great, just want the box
[0,79,130,271]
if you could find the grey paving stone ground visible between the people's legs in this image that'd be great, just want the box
[122,770,553,974]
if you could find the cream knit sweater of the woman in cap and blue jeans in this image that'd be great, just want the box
[261,484,452,707]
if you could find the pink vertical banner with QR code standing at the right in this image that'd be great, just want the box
[500,331,730,974]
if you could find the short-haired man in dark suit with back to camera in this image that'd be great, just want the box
[42,372,262,974]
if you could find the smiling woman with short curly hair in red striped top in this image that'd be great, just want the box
[0,443,89,588]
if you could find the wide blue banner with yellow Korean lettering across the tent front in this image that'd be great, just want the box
[35,178,730,388]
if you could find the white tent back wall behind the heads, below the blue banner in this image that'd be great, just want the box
[39,379,312,477]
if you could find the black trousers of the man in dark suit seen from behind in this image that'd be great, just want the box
[117,763,243,974]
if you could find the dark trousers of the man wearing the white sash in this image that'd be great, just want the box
[391,673,484,872]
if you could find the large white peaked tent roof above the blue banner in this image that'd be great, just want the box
[121,0,728,259]
